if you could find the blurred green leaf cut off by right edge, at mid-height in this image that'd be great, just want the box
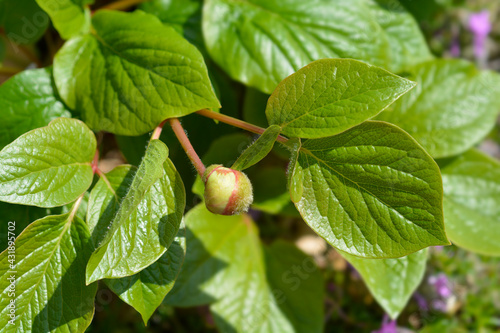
[441,149,500,256]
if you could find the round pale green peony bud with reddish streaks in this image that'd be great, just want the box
[203,164,253,215]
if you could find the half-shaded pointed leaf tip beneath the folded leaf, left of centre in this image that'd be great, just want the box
[105,223,186,325]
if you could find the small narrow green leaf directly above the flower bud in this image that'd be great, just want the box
[231,125,280,170]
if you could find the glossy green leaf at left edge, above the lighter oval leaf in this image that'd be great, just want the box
[0,68,71,148]
